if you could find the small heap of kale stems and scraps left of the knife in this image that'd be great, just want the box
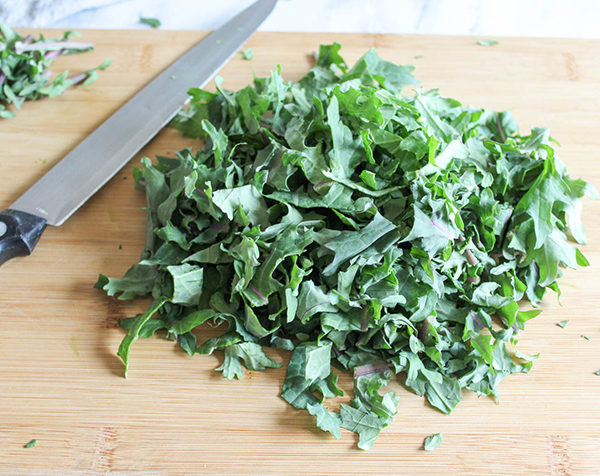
[0,23,111,118]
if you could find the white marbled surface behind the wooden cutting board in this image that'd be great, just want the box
[38,0,600,38]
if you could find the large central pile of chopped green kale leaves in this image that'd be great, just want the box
[96,44,597,449]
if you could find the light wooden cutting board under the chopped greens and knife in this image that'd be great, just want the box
[0,31,600,476]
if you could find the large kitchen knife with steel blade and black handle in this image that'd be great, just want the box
[0,0,277,265]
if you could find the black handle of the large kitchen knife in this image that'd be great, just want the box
[0,209,46,265]
